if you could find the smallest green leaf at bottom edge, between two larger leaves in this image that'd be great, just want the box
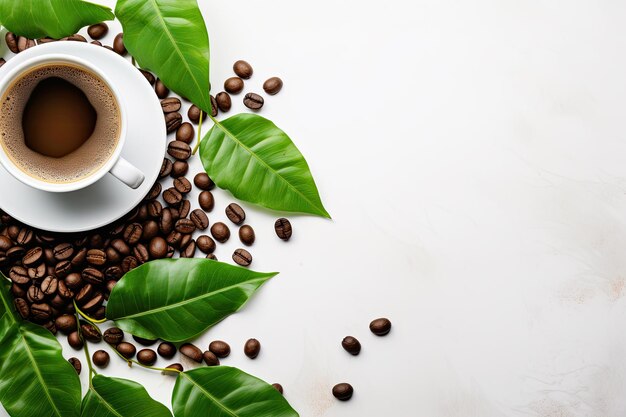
[81,375,172,417]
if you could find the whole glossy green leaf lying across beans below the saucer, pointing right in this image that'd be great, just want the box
[107,258,276,342]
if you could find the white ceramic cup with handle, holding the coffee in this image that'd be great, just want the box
[0,53,145,193]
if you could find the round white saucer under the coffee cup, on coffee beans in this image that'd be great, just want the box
[0,42,167,233]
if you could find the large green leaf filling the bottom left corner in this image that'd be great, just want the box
[0,274,81,417]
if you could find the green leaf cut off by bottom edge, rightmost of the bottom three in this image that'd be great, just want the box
[172,366,298,417]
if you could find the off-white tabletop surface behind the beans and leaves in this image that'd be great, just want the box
[6,0,626,417]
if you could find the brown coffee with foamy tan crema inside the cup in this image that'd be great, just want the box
[0,63,121,183]
